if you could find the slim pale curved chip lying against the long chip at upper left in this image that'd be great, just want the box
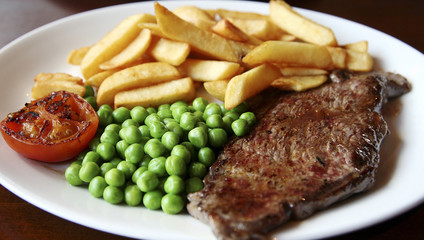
[99,29,152,70]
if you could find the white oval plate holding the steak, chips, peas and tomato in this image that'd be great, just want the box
[0,1,424,239]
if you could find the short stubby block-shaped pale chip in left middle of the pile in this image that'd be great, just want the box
[148,36,190,66]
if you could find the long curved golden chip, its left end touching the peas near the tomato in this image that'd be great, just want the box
[97,62,180,106]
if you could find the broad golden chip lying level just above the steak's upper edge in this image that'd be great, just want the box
[243,41,333,69]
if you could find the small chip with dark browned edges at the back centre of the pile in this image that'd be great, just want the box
[211,19,262,45]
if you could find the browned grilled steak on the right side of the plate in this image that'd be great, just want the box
[187,71,411,239]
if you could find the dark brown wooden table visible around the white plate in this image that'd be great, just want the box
[0,0,424,240]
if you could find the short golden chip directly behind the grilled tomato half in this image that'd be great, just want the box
[31,73,85,99]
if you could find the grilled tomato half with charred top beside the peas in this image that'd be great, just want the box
[0,91,99,162]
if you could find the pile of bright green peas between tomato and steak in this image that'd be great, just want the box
[65,91,256,214]
